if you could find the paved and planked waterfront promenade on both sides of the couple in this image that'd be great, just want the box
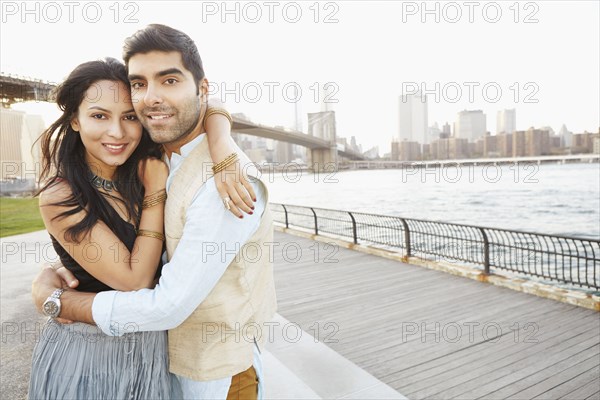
[1,228,600,399]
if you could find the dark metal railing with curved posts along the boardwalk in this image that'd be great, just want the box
[271,203,600,290]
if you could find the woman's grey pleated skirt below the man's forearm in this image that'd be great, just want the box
[29,319,178,400]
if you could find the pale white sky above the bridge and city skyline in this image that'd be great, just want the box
[0,0,600,154]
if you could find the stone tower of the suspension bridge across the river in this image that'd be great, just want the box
[308,111,338,172]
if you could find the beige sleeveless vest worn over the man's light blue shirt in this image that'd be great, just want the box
[165,138,277,381]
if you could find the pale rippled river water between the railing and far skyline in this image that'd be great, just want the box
[264,163,600,239]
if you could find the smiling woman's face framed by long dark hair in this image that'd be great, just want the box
[71,81,142,175]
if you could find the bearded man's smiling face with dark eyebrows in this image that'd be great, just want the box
[128,51,206,144]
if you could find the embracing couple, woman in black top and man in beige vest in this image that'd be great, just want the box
[29,25,276,399]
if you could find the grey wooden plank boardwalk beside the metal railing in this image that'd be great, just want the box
[275,232,600,399]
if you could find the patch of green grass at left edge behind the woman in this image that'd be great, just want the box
[0,197,44,237]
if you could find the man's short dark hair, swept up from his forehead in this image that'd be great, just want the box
[123,24,204,87]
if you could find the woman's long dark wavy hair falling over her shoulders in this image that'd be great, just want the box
[37,58,160,242]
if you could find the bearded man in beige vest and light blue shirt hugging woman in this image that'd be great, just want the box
[33,25,276,399]
